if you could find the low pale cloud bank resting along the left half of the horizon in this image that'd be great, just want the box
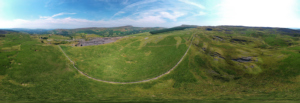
[0,16,167,28]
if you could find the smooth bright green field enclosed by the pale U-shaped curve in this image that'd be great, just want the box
[62,33,191,82]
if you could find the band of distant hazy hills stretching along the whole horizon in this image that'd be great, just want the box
[6,24,300,37]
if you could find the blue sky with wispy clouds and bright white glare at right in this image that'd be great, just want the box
[0,0,300,29]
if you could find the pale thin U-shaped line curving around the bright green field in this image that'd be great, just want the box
[58,36,194,84]
